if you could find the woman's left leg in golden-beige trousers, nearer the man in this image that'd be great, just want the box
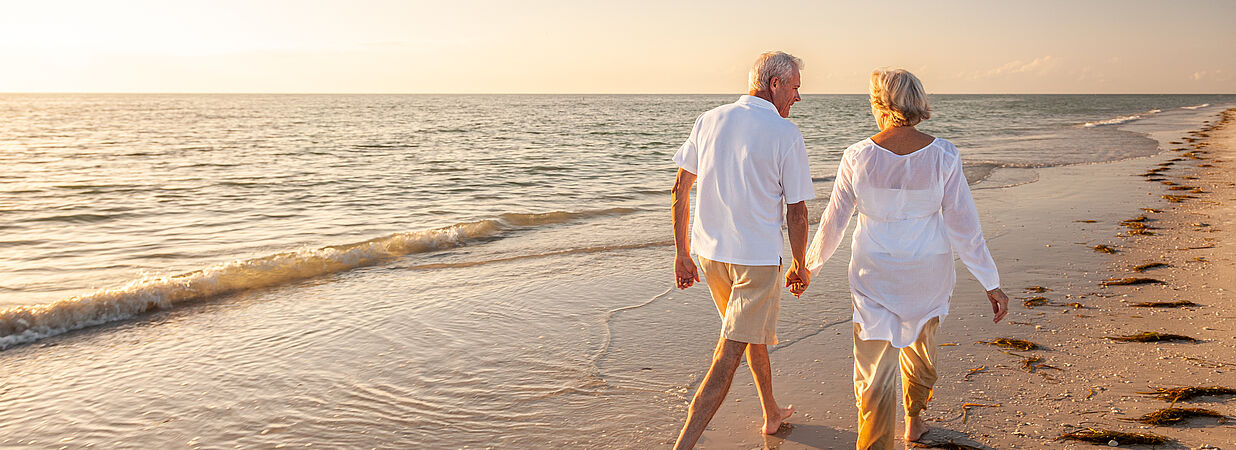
[854,324,897,450]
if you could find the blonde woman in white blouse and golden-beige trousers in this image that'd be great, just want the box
[807,69,1009,449]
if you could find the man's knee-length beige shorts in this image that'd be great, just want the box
[700,257,781,345]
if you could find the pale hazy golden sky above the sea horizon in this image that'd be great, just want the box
[0,0,1236,94]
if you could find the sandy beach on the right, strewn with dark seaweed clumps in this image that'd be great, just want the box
[700,110,1236,449]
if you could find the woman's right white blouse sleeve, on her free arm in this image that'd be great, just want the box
[941,157,1000,291]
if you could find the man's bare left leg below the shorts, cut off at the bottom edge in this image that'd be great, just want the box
[674,339,747,449]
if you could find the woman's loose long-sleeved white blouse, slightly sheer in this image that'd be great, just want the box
[807,138,1000,347]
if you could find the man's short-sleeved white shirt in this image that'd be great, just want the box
[674,95,816,266]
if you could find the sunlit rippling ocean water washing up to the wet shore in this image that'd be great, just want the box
[0,94,1236,448]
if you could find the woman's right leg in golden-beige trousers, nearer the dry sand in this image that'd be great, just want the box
[900,318,939,441]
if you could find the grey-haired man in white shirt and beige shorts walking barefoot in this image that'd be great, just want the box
[671,52,815,449]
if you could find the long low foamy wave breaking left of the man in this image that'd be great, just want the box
[0,208,635,350]
